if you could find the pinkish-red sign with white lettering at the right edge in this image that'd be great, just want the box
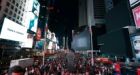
[132,6,140,28]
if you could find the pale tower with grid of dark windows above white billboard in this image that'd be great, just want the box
[0,0,28,25]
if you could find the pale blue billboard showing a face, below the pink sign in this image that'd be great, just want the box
[131,36,140,59]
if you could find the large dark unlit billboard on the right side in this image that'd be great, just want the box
[98,28,133,57]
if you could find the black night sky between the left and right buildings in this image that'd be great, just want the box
[39,0,78,46]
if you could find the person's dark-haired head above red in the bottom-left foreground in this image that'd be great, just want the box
[8,65,25,75]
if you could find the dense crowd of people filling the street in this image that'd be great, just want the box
[1,51,138,75]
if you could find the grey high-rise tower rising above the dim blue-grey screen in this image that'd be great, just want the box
[79,0,105,27]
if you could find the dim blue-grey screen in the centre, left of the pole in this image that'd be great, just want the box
[71,30,91,51]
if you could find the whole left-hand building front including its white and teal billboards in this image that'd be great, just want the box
[0,0,40,56]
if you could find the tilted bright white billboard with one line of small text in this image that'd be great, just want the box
[0,18,27,42]
